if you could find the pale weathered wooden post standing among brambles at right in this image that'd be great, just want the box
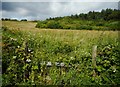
[92,45,97,77]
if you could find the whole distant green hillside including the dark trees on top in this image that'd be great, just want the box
[36,9,120,30]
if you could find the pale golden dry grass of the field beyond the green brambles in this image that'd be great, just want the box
[2,21,118,44]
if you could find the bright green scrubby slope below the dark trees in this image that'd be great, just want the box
[36,17,119,30]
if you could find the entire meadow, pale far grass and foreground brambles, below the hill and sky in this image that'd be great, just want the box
[1,21,120,86]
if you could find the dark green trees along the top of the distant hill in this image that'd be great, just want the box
[47,8,120,21]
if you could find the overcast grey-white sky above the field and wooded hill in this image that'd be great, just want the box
[0,2,118,20]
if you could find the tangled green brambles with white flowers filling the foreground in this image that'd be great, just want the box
[2,27,120,86]
